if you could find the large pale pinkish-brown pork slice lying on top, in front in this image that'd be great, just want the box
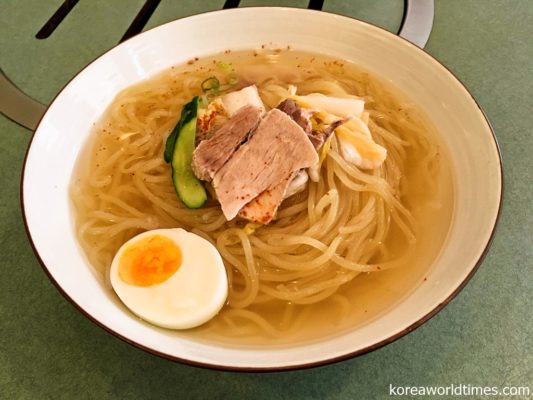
[213,109,318,220]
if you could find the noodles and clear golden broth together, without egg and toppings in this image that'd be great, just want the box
[71,49,453,343]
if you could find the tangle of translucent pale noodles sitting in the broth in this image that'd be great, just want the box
[71,52,438,337]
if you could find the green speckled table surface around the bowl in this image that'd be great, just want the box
[0,0,533,399]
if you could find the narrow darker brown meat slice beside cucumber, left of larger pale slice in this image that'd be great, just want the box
[192,106,262,181]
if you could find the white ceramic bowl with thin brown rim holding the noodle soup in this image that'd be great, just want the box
[22,8,502,370]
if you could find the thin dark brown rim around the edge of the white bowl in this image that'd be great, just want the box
[20,6,504,372]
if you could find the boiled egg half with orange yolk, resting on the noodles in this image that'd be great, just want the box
[110,228,228,329]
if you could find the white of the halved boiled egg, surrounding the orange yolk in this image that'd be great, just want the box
[110,228,228,329]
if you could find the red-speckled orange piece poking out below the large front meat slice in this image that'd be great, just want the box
[239,172,297,225]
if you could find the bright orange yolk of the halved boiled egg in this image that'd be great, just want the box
[118,235,181,286]
